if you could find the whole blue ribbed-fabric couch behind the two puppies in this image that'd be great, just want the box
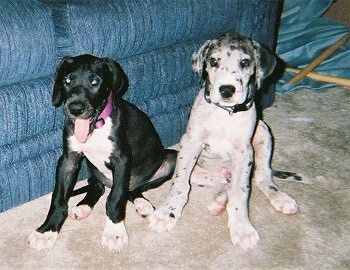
[0,0,281,212]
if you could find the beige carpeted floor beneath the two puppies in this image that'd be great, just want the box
[0,88,350,269]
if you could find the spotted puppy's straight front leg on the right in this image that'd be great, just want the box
[226,143,260,249]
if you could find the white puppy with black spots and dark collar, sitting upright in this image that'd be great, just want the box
[149,33,297,249]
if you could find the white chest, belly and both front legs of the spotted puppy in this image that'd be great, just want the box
[149,89,259,248]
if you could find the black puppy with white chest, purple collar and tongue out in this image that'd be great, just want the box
[28,55,177,251]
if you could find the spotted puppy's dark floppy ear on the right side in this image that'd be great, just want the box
[252,41,277,89]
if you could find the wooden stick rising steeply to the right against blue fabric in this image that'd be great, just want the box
[288,33,350,83]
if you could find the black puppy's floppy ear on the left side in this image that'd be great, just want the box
[52,56,73,107]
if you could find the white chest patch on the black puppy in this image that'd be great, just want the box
[68,117,113,180]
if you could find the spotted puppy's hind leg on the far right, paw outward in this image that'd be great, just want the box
[253,120,297,214]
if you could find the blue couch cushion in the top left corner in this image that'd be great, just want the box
[0,0,57,86]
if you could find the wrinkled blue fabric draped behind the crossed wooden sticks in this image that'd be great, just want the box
[276,0,350,92]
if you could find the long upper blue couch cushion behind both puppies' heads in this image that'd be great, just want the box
[42,0,278,59]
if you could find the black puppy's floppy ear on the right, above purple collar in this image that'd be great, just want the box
[104,58,129,100]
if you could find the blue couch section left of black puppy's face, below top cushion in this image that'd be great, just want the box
[0,77,65,147]
